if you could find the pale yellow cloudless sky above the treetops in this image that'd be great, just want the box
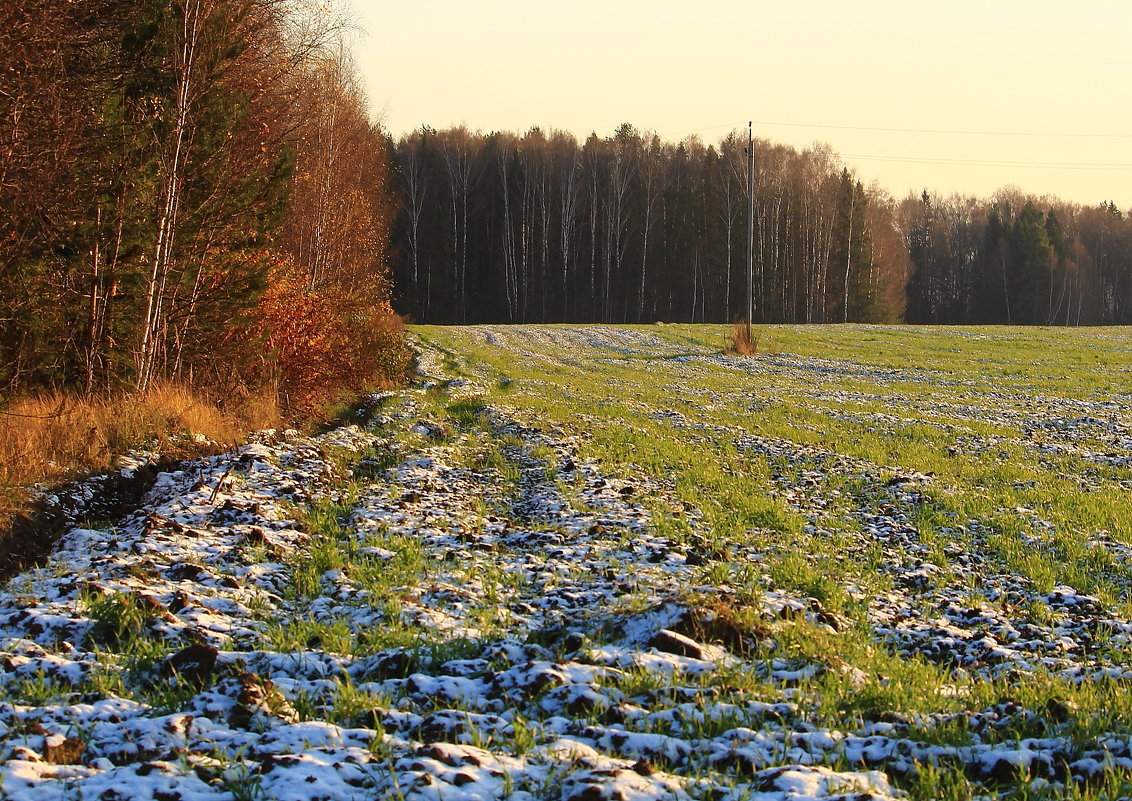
[351,0,1132,210]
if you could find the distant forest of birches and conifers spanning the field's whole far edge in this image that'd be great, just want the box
[392,124,1132,325]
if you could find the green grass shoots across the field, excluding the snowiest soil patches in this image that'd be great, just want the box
[3,326,1132,800]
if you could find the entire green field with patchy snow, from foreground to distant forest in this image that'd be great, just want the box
[0,325,1132,801]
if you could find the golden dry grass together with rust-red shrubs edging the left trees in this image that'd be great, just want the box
[0,307,411,531]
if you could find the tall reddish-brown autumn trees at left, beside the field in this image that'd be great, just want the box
[0,0,403,414]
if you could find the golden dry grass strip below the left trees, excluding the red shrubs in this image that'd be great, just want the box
[0,384,280,528]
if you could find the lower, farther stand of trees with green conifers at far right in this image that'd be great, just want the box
[900,189,1132,326]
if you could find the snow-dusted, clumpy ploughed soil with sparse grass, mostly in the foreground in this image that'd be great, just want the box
[0,328,1132,801]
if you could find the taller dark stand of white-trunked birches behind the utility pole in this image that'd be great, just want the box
[393,124,908,322]
